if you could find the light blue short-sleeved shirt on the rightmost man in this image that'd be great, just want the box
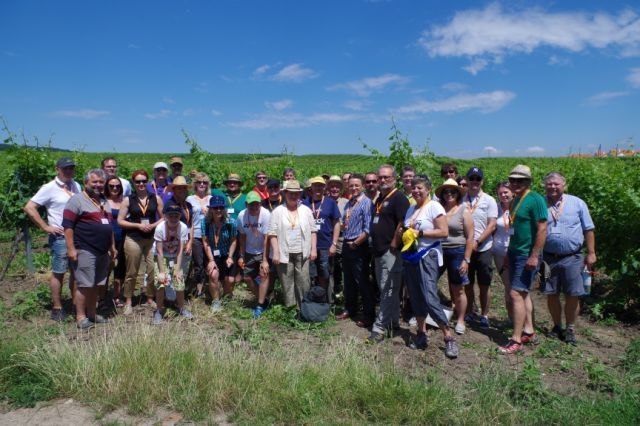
[544,194,595,254]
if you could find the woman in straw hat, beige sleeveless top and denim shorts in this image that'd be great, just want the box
[436,179,473,334]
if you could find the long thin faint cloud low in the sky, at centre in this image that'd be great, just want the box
[227,113,364,130]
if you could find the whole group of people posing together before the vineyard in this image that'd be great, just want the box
[24,157,596,358]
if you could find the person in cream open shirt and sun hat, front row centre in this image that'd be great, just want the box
[268,180,317,310]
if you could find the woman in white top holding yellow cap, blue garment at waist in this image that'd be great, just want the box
[398,175,458,358]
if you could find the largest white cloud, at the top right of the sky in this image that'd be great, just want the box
[418,3,640,73]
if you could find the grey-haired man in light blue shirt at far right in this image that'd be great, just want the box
[543,172,596,345]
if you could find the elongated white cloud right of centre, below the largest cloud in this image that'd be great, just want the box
[396,90,516,114]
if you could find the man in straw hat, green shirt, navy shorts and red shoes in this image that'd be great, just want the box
[500,164,547,354]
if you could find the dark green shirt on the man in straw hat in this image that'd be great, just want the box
[509,191,548,256]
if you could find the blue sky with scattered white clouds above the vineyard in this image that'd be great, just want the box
[0,0,640,158]
